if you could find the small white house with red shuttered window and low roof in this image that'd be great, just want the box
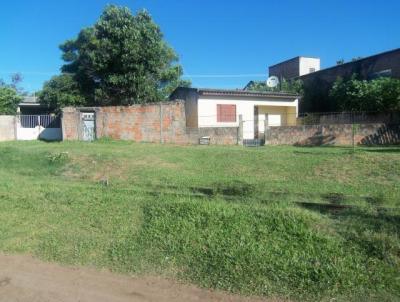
[170,87,300,139]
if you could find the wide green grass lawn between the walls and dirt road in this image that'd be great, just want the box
[0,140,400,301]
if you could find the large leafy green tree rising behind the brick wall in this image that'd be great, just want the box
[40,5,190,107]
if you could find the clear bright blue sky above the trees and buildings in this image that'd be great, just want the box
[0,0,400,91]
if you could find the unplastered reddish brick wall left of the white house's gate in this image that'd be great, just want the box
[62,101,238,144]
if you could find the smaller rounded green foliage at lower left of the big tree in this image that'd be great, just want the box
[38,74,88,109]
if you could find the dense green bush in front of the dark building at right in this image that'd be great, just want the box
[330,75,400,112]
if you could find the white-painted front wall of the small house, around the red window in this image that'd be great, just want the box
[197,96,298,139]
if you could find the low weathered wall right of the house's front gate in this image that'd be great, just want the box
[265,124,400,146]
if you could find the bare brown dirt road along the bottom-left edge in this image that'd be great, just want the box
[0,255,279,302]
